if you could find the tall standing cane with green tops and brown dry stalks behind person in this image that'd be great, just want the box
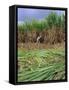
[18,12,65,44]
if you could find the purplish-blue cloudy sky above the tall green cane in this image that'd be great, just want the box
[18,8,65,23]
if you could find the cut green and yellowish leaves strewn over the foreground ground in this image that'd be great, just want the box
[18,48,65,82]
